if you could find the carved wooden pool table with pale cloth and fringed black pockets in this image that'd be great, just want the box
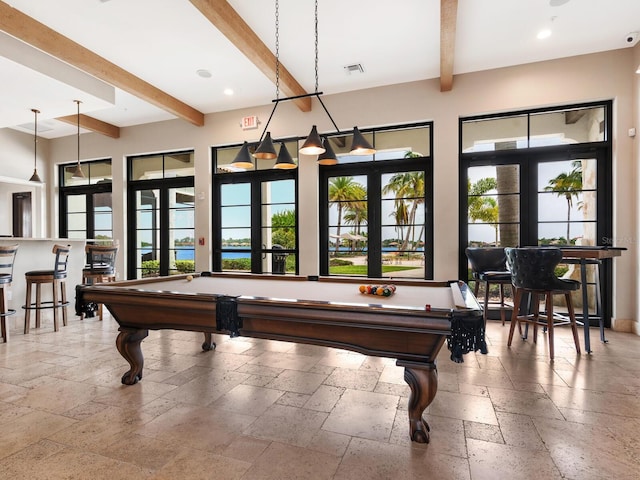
[77,272,486,443]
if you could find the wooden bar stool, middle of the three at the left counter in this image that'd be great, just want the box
[22,245,71,334]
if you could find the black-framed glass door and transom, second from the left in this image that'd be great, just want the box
[127,152,195,278]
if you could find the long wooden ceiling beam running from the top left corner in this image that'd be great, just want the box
[0,1,204,127]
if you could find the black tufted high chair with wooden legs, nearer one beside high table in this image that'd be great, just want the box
[505,247,580,360]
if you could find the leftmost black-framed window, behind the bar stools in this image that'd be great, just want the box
[59,160,113,240]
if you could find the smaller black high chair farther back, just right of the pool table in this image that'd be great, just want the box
[465,247,512,325]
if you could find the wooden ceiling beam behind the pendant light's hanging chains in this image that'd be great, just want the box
[190,0,311,112]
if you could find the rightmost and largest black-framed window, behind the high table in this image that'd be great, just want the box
[460,102,613,323]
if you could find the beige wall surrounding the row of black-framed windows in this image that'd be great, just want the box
[0,47,640,332]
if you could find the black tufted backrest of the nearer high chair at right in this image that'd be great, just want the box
[505,247,567,291]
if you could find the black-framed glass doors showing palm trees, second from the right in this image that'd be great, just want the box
[320,124,433,278]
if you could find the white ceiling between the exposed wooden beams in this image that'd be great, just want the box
[0,0,640,138]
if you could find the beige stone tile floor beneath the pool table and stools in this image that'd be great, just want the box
[0,310,640,480]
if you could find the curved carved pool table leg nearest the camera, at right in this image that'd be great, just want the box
[396,361,438,443]
